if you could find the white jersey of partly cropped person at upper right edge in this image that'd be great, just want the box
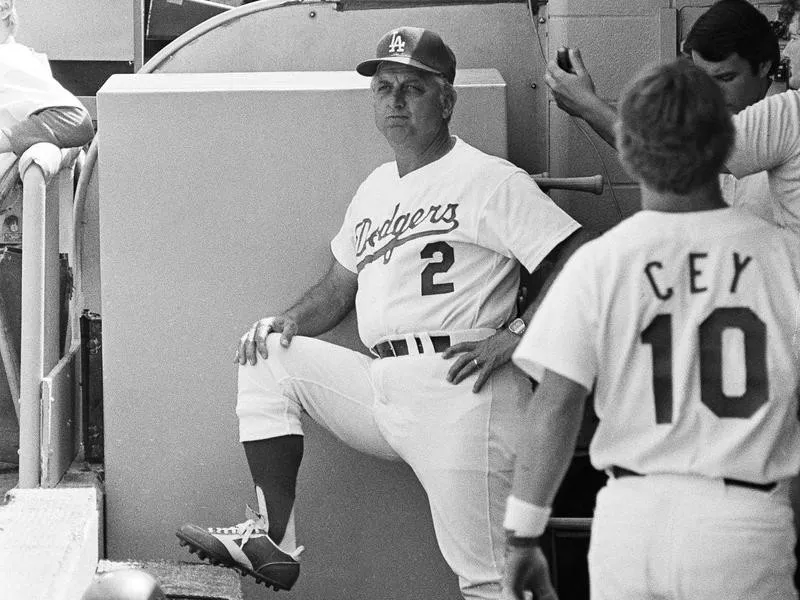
[727,91,800,233]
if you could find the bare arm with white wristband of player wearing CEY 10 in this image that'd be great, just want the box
[503,370,589,600]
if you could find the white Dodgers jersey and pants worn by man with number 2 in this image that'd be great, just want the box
[241,140,578,600]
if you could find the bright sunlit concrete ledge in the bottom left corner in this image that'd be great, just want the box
[0,486,100,600]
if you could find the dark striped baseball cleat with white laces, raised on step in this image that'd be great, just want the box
[175,506,303,591]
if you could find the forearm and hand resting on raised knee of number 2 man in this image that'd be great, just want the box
[236,251,358,365]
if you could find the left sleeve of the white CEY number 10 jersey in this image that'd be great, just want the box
[512,242,599,390]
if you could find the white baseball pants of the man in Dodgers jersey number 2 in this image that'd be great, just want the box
[236,331,532,600]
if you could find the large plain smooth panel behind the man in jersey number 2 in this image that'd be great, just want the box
[98,70,507,600]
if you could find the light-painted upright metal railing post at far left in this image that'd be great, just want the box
[19,144,80,488]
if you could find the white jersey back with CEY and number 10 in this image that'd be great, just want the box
[514,208,800,483]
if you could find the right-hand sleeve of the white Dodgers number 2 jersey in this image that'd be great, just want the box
[477,171,580,272]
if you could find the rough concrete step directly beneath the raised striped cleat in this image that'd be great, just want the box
[97,560,243,600]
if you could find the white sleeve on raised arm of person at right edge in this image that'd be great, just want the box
[727,91,800,178]
